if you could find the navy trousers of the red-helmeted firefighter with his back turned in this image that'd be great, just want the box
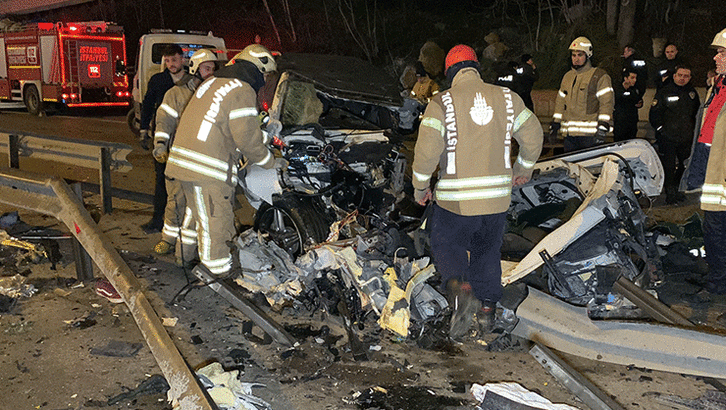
[431,204,506,303]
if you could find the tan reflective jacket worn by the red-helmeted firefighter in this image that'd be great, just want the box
[413,68,543,216]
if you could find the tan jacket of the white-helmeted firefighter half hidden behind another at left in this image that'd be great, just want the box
[154,77,201,151]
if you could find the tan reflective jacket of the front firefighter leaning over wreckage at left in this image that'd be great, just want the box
[166,77,275,186]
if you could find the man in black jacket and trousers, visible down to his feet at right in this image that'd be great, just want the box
[650,64,701,204]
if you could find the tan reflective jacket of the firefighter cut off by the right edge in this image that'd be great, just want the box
[701,75,726,212]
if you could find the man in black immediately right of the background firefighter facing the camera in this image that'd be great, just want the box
[613,69,643,142]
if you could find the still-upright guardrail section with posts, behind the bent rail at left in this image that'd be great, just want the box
[0,130,132,214]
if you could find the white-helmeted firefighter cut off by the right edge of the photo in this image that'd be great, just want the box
[688,29,726,295]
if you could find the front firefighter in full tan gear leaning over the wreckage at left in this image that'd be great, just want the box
[166,44,276,275]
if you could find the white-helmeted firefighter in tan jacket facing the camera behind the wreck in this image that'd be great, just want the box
[550,37,614,152]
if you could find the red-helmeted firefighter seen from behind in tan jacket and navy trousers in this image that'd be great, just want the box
[413,45,542,340]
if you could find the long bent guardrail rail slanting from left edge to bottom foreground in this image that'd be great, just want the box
[0,169,217,410]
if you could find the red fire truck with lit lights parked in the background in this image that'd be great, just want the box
[0,21,131,115]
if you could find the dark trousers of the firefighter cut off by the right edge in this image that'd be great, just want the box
[703,211,726,294]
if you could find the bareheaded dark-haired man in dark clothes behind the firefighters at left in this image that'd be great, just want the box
[139,44,192,234]
